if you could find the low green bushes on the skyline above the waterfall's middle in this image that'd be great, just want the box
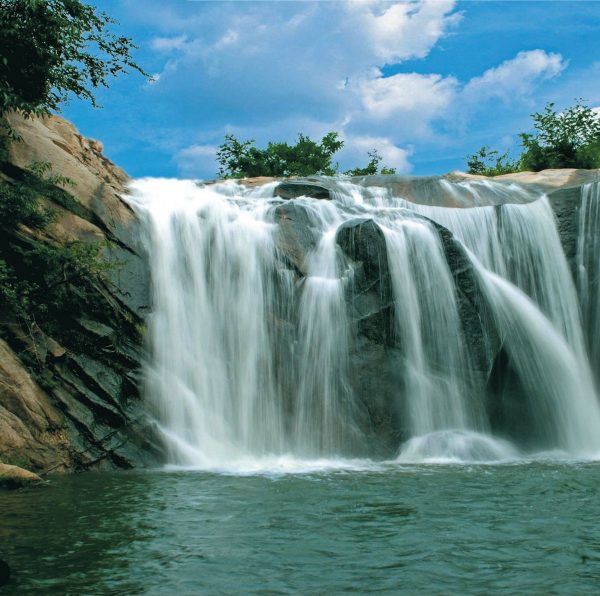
[217,132,395,178]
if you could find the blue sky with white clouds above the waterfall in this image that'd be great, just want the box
[63,0,600,178]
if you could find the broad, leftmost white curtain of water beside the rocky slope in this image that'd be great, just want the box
[127,180,283,465]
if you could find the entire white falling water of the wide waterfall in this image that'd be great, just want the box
[129,179,600,471]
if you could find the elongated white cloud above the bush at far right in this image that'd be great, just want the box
[464,50,567,102]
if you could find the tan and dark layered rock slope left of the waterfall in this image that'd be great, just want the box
[0,115,160,472]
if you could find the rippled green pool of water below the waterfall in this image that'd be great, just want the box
[0,462,600,596]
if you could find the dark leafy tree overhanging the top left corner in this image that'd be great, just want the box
[0,0,148,116]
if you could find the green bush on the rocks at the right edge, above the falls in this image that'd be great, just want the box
[467,100,600,176]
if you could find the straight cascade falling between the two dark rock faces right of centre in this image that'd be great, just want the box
[383,218,482,435]
